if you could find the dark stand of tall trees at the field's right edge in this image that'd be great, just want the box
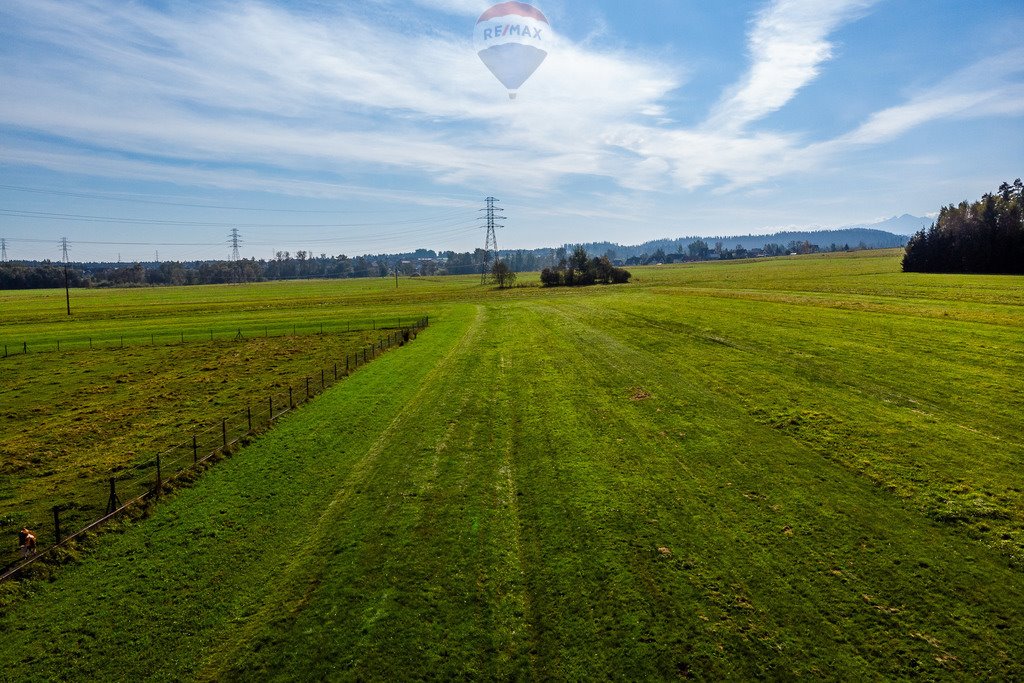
[903,178,1024,274]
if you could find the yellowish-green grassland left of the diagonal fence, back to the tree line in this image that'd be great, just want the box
[0,281,432,566]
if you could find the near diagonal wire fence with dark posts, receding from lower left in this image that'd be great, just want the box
[0,316,430,582]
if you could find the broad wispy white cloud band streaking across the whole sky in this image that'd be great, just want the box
[0,0,1024,205]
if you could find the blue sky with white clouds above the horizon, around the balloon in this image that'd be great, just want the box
[0,0,1024,261]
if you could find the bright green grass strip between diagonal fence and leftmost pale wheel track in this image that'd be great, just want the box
[0,307,468,680]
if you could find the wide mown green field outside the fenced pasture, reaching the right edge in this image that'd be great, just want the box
[0,252,1024,680]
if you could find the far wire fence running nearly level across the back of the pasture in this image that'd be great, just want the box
[0,316,418,358]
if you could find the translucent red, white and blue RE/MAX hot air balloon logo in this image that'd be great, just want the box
[474,2,552,99]
